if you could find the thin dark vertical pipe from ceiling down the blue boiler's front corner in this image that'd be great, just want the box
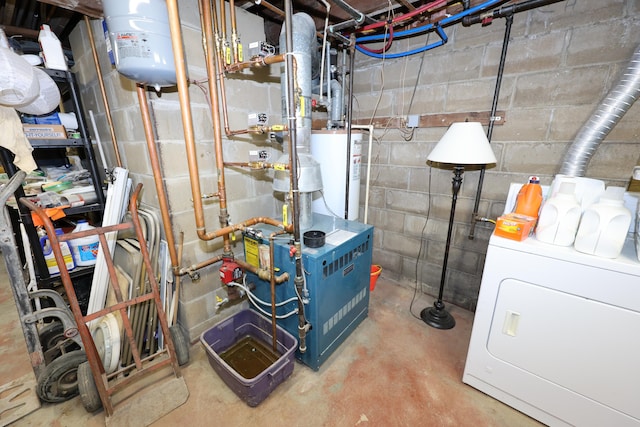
[284,0,310,353]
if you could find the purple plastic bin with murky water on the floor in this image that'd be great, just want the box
[200,310,298,406]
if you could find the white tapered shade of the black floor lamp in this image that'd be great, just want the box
[427,122,497,165]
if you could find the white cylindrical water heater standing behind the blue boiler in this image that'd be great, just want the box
[311,130,362,221]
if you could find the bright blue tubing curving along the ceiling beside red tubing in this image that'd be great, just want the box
[356,0,504,59]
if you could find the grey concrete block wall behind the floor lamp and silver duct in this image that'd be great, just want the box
[353,0,640,314]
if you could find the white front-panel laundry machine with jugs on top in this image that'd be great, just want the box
[463,236,640,427]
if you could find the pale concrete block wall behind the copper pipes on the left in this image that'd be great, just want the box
[70,0,282,341]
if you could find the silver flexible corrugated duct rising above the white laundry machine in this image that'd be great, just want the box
[559,46,640,176]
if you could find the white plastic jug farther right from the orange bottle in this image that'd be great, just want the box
[574,187,631,258]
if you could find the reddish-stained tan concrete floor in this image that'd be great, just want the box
[0,268,540,427]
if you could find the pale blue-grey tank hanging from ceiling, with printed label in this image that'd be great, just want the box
[103,0,176,90]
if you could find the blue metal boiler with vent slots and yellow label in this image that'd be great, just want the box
[244,214,373,370]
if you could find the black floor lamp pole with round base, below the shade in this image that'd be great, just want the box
[420,166,464,329]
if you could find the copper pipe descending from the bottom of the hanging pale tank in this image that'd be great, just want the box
[136,83,180,328]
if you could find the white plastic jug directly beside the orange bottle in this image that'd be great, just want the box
[536,182,582,246]
